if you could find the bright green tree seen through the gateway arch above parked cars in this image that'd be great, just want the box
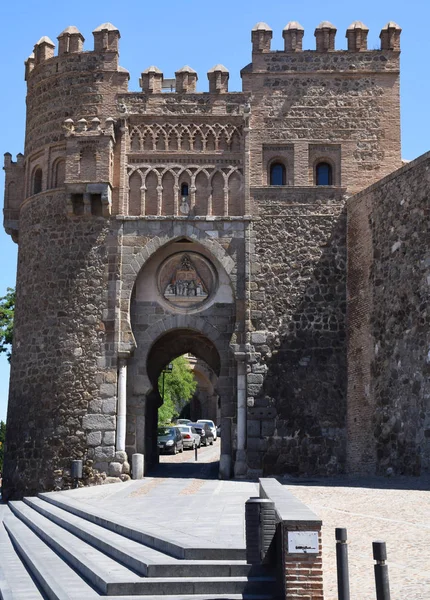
[158,356,197,425]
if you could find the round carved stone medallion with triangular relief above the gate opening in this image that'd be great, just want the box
[158,252,215,308]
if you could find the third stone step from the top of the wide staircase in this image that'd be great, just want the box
[10,502,275,597]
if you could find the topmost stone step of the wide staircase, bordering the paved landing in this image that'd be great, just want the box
[39,492,246,561]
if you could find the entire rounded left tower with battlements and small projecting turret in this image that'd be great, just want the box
[3,23,128,499]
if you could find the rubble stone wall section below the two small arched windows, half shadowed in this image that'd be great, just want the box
[248,188,346,475]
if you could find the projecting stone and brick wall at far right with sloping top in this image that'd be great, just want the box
[348,154,430,475]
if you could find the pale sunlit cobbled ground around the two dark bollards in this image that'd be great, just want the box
[283,477,430,600]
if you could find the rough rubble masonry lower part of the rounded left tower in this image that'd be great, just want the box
[3,191,117,498]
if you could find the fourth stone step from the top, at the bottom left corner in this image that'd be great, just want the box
[4,514,100,600]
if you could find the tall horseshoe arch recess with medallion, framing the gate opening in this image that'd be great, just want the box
[125,238,237,477]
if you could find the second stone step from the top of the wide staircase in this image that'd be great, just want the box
[24,498,266,577]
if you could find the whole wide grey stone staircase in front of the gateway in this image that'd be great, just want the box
[0,493,278,600]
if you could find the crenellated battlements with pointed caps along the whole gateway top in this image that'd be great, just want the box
[25,21,402,94]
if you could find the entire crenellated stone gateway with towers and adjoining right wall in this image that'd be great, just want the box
[3,22,430,499]
